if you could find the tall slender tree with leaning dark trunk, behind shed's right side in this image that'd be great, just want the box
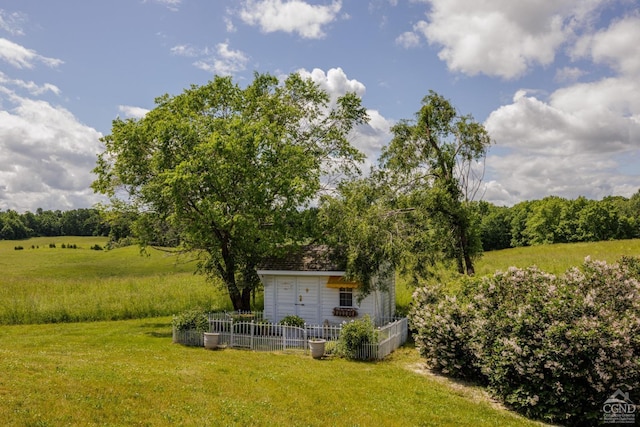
[381,91,491,274]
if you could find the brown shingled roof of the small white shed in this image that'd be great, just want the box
[258,245,346,272]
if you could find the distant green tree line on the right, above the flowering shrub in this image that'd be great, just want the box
[477,190,640,251]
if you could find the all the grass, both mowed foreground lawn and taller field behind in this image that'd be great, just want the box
[0,238,640,426]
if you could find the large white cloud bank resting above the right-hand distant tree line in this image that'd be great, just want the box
[485,78,640,204]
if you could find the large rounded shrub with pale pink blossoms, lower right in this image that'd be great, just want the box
[410,257,640,425]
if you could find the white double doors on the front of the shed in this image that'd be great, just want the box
[276,276,321,324]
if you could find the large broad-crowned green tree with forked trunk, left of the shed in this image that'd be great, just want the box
[93,74,367,310]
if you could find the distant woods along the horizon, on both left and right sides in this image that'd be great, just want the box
[0,190,640,251]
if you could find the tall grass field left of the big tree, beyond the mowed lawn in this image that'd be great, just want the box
[0,237,230,325]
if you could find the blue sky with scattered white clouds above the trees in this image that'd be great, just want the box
[0,0,640,212]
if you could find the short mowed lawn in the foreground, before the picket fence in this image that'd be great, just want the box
[0,317,539,426]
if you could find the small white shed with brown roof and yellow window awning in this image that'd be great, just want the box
[258,245,395,325]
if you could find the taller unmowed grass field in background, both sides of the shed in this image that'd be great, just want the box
[0,237,640,325]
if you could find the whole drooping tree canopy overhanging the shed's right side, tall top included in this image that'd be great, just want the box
[320,92,491,294]
